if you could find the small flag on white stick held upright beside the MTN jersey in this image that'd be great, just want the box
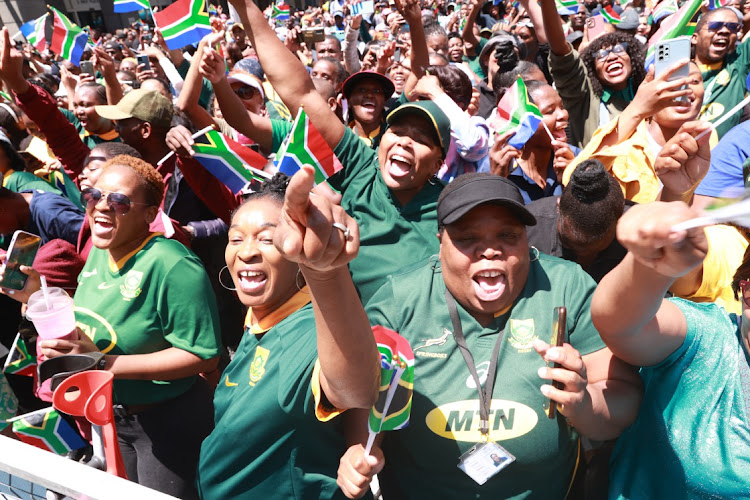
[365,325,414,455]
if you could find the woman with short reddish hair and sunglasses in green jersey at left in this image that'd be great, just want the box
[40,156,220,498]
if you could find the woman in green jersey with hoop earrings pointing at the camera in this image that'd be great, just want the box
[198,170,379,500]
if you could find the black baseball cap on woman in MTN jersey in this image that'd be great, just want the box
[438,172,536,227]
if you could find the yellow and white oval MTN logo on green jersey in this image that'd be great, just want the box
[425,399,539,443]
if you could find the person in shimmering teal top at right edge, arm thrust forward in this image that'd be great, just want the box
[591,203,750,499]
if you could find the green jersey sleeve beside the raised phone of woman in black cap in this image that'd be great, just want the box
[565,268,606,355]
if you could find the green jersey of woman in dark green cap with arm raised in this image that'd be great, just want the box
[272,121,445,304]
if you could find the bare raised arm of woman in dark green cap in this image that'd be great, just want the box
[231,0,346,148]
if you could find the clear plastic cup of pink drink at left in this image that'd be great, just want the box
[26,287,76,339]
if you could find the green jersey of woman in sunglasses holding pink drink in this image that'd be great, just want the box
[74,233,221,405]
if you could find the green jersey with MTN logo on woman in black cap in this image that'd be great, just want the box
[367,254,604,500]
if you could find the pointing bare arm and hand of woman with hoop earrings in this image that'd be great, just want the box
[274,166,380,409]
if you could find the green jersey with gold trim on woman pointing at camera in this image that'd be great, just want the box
[198,293,354,499]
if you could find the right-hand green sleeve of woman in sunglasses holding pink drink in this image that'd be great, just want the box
[156,254,221,359]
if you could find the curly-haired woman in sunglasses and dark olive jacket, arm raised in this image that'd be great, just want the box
[530,0,646,148]
